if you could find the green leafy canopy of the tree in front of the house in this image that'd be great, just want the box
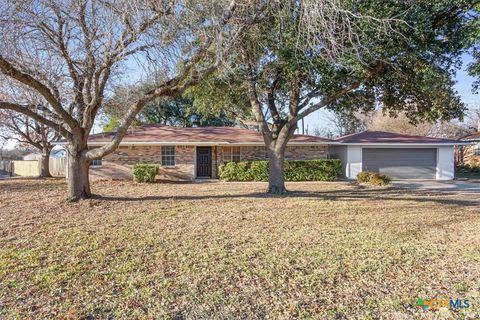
[194,0,480,129]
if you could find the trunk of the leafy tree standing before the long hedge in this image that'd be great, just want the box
[267,148,287,194]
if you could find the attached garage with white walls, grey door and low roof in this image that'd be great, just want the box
[331,130,464,180]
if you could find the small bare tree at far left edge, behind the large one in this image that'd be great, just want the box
[0,110,61,177]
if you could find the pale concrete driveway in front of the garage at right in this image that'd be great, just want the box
[392,180,480,194]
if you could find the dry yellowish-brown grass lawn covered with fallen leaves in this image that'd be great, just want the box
[0,180,480,319]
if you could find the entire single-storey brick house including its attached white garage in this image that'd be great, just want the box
[56,125,468,181]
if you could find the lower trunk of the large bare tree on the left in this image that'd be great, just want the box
[67,150,92,201]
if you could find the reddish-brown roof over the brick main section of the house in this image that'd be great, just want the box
[80,125,333,145]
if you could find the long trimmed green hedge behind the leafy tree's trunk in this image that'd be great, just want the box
[220,159,342,181]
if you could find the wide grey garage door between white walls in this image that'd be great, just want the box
[362,148,437,179]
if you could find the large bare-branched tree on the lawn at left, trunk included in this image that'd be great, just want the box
[0,0,262,199]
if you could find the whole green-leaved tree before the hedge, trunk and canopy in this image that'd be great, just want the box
[193,0,472,194]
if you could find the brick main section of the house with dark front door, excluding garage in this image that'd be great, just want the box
[83,125,331,181]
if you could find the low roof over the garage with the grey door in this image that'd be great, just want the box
[335,130,461,145]
